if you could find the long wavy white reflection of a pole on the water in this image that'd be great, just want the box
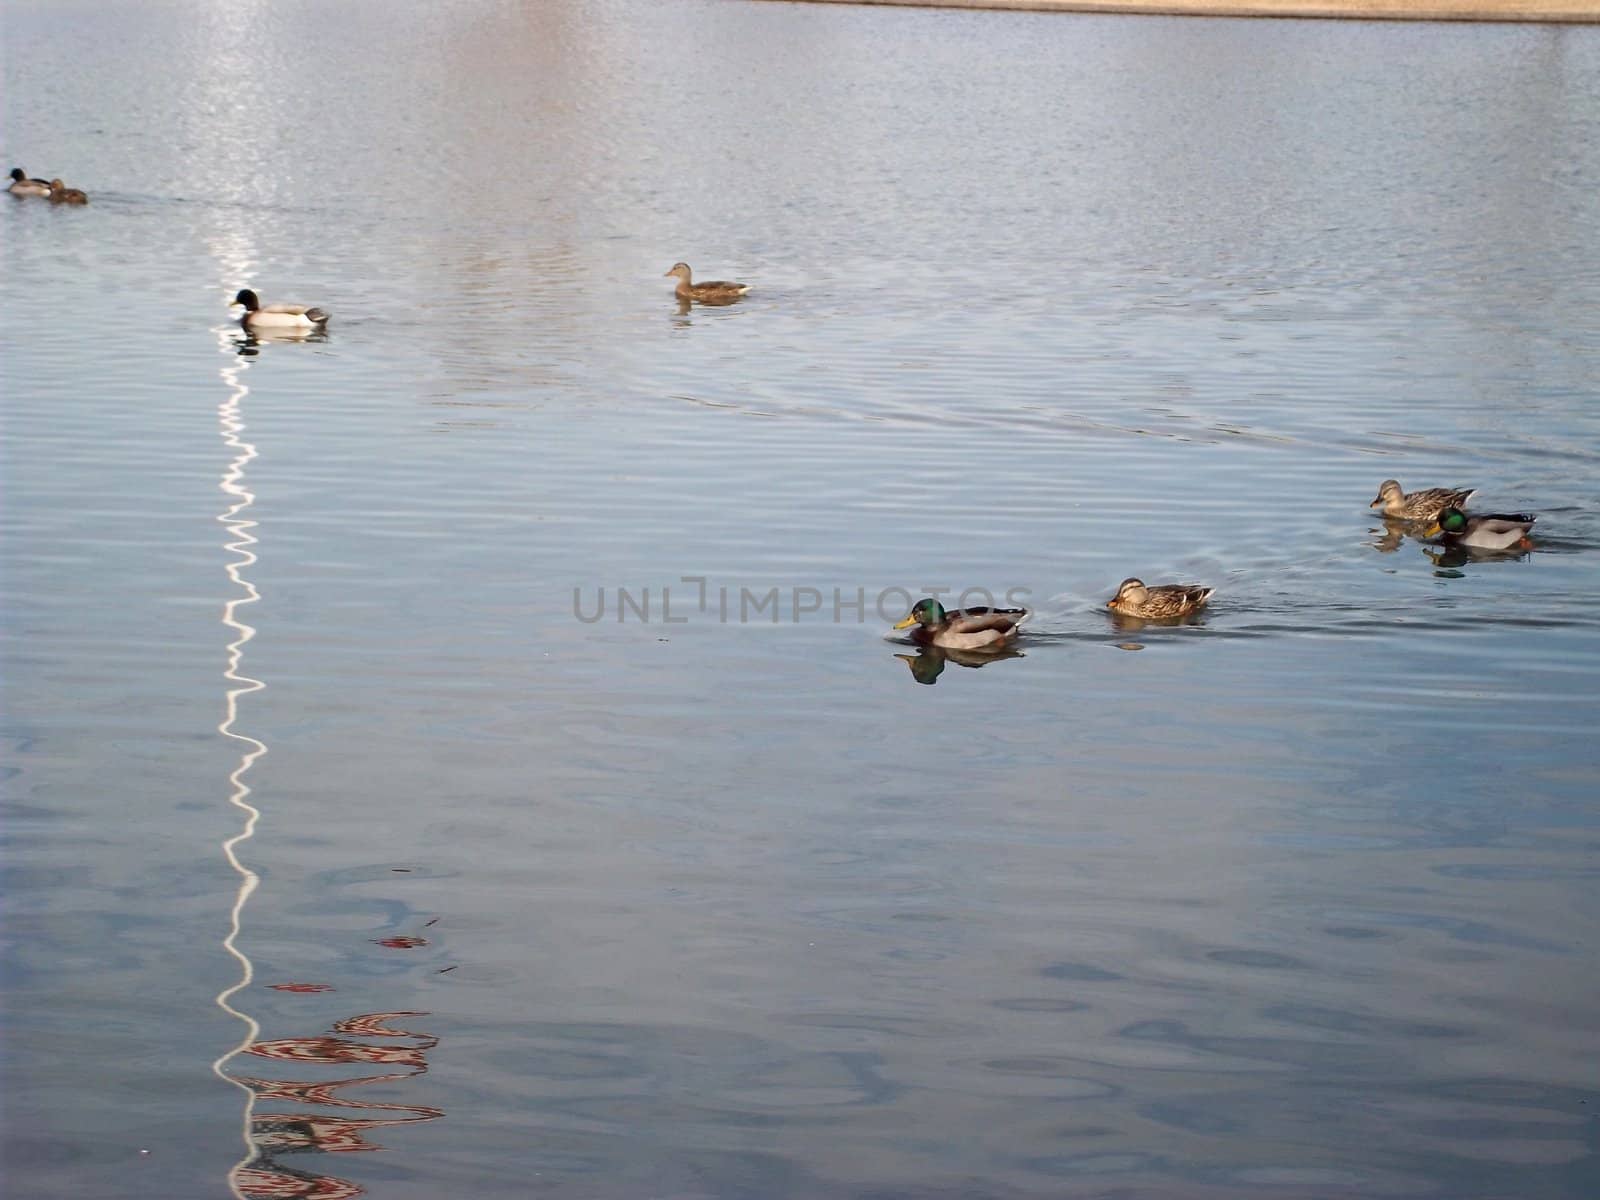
[211,326,267,1200]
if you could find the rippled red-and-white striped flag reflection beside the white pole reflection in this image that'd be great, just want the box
[232,1011,445,1200]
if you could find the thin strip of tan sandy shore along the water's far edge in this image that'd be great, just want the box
[764,0,1600,22]
